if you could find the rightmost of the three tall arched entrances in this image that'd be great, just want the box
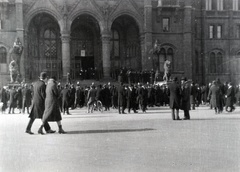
[110,15,142,76]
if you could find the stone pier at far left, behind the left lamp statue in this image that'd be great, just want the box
[15,0,26,79]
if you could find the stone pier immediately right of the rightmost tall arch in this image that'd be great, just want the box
[142,0,153,70]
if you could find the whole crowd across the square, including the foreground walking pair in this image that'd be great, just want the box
[0,72,240,134]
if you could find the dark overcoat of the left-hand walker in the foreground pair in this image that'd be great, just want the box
[29,80,46,119]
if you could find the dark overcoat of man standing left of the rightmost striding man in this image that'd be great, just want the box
[208,85,221,108]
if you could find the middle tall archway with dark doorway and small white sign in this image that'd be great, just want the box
[71,14,102,79]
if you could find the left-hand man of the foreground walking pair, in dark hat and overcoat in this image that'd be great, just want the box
[26,72,56,134]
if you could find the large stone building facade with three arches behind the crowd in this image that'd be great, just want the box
[0,0,240,86]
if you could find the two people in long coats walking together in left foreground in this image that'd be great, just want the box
[26,72,66,134]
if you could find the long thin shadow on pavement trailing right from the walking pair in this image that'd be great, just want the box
[67,128,155,134]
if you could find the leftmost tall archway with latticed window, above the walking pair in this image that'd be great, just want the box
[26,13,62,80]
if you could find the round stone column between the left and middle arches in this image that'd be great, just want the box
[61,33,71,81]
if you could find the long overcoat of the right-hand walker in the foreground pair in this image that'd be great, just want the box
[43,79,62,121]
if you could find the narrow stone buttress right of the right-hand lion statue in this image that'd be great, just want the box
[183,1,194,79]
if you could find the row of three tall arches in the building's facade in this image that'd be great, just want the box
[25,13,142,80]
